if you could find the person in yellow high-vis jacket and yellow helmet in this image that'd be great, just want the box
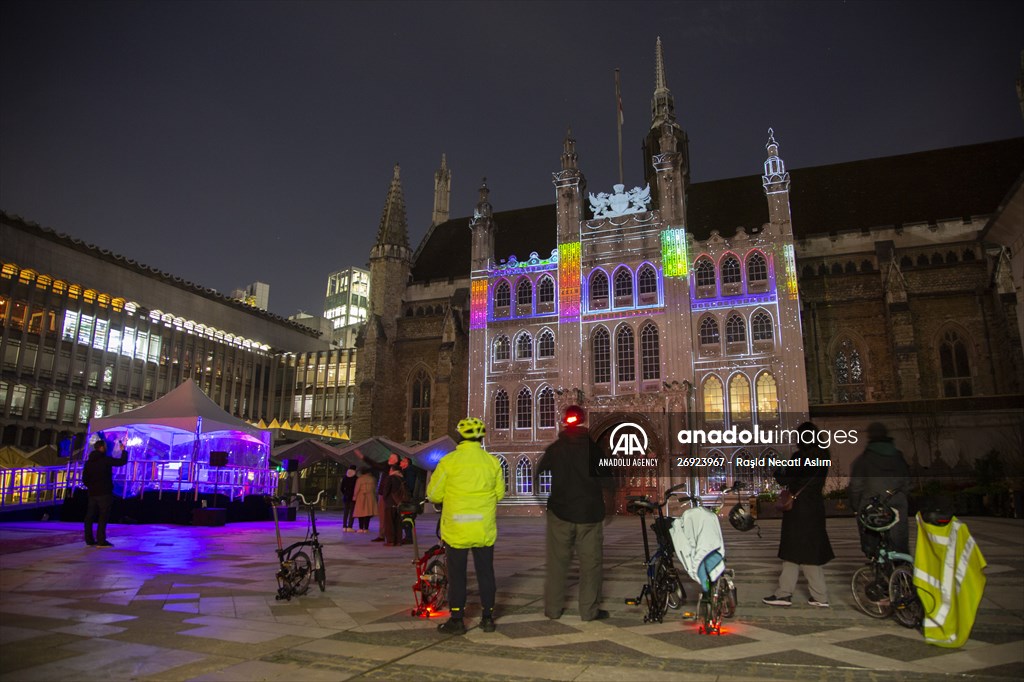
[427,417,505,635]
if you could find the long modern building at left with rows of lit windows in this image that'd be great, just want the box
[0,214,355,447]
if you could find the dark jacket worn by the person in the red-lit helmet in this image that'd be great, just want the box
[537,426,611,523]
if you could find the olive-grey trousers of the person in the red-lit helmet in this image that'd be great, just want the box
[544,511,604,621]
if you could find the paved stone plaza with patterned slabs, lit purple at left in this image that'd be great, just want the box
[0,512,1024,682]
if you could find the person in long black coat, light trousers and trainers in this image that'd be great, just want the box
[762,422,836,607]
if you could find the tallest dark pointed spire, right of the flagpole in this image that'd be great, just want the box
[643,38,690,209]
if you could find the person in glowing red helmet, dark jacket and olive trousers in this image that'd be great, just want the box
[537,406,610,621]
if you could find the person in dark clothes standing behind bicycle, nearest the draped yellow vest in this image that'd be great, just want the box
[850,422,910,557]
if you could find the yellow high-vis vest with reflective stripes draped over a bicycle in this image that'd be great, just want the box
[913,513,986,648]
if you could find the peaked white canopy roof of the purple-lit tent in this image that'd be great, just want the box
[89,379,263,438]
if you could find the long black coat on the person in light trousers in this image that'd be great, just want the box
[775,445,836,566]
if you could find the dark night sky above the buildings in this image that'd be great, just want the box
[0,0,1024,315]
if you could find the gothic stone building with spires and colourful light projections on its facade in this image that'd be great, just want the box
[353,44,1024,502]
